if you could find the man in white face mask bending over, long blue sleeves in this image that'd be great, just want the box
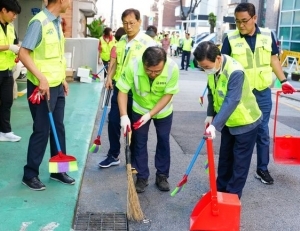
[194,42,262,198]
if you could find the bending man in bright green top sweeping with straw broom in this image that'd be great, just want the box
[116,47,179,193]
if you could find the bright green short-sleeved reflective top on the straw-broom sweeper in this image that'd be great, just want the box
[116,58,179,119]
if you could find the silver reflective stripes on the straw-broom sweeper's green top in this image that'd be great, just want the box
[132,59,176,118]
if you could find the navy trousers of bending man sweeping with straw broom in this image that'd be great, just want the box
[132,112,173,179]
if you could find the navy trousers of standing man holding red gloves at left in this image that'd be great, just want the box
[23,80,66,180]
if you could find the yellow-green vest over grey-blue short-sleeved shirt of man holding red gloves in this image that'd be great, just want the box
[27,11,66,87]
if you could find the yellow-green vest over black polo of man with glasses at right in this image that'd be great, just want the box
[228,28,272,91]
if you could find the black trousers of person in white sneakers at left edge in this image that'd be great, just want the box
[0,70,14,133]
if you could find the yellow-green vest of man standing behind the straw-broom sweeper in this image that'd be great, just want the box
[113,34,155,81]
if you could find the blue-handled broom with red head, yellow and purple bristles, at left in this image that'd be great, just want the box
[47,100,78,173]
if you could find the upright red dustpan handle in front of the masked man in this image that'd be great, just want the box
[206,137,219,215]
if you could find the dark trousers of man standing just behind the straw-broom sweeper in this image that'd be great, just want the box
[107,82,134,158]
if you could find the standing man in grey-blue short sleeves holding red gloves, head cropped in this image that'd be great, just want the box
[19,0,75,191]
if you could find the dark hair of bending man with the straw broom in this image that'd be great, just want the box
[142,47,167,67]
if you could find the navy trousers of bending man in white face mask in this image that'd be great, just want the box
[217,126,258,198]
